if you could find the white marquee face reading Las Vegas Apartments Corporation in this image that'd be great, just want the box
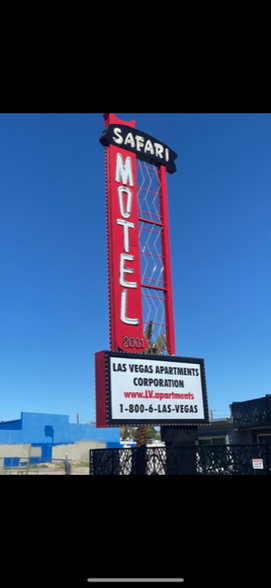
[109,354,208,423]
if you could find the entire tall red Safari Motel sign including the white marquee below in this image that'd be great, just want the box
[95,113,208,430]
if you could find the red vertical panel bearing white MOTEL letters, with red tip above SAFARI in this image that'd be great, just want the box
[104,113,148,352]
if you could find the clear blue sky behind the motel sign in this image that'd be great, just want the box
[0,113,271,422]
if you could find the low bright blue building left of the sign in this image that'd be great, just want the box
[0,412,121,465]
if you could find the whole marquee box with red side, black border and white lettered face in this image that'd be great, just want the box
[95,351,209,427]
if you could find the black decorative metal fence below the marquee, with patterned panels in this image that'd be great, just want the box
[90,444,271,476]
